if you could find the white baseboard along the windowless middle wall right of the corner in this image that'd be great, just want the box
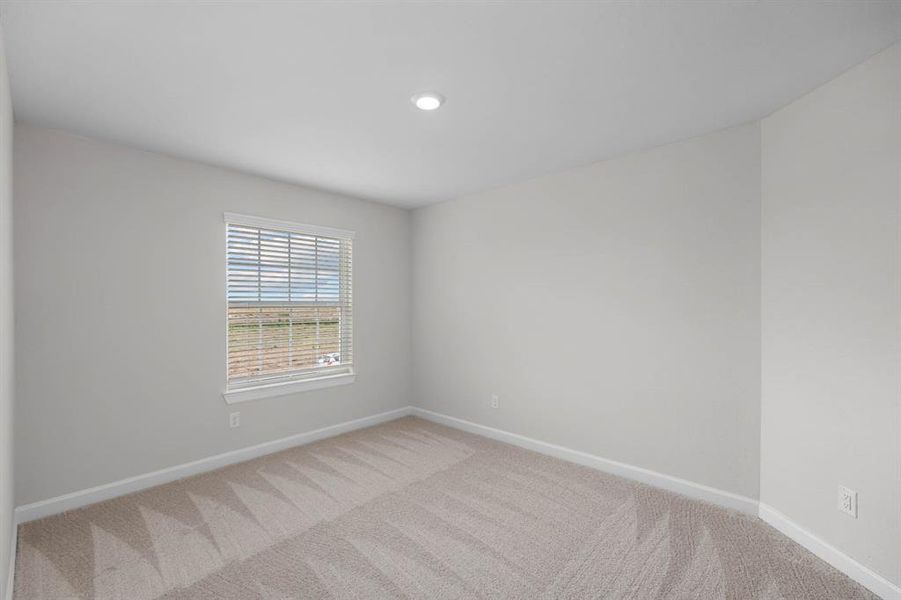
[413,407,757,515]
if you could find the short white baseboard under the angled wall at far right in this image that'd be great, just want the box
[759,502,901,600]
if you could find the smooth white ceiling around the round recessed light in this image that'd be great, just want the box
[0,0,901,206]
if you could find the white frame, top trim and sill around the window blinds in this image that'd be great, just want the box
[222,212,356,404]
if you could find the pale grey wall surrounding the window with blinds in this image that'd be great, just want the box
[15,126,411,505]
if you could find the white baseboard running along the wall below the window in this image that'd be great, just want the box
[16,406,412,523]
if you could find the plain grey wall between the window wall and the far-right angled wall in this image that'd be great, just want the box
[413,124,760,498]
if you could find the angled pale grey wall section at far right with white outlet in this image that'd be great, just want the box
[761,45,901,584]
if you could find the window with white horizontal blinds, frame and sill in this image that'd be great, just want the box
[225,213,353,402]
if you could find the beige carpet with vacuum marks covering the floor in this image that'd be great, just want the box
[15,418,875,600]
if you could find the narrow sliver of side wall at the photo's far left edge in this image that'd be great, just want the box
[0,29,15,598]
